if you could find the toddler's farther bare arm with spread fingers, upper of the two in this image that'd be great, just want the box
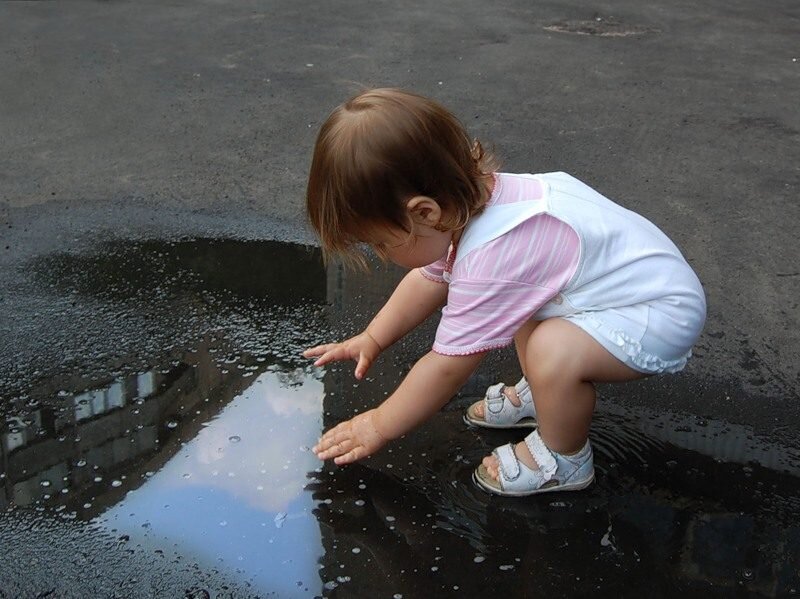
[303,268,447,379]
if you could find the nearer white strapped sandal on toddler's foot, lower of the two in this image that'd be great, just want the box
[472,431,594,497]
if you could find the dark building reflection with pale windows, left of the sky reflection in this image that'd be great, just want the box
[0,340,258,518]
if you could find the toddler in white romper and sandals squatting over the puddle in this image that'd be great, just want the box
[304,89,706,496]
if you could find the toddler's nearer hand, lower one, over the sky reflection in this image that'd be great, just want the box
[313,410,388,465]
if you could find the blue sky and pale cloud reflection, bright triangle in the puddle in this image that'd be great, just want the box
[97,371,324,597]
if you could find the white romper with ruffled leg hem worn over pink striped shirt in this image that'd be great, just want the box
[455,172,706,373]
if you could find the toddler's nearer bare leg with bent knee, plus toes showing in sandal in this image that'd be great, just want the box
[483,318,646,479]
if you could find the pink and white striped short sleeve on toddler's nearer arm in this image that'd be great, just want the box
[433,214,580,355]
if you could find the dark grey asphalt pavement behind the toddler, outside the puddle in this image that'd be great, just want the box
[0,0,800,596]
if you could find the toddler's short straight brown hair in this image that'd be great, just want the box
[306,88,496,263]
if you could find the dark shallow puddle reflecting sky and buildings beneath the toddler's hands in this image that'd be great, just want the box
[0,240,800,597]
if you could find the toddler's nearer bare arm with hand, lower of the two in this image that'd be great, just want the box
[314,352,485,464]
